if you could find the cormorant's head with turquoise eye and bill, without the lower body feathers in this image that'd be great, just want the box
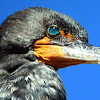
[0,7,100,70]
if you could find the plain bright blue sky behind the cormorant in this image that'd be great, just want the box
[0,0,100,100]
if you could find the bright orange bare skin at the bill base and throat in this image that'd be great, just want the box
[33,37,81,70]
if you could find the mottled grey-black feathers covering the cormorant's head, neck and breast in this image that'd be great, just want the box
[0,7,99,100]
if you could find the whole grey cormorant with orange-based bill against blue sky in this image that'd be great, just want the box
[0,7,100,100]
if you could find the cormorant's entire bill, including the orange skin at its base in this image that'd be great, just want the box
[33,37,100,70]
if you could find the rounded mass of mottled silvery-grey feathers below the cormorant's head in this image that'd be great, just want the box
[0,62,66,100]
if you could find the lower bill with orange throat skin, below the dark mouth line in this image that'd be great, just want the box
[34,44,100,70]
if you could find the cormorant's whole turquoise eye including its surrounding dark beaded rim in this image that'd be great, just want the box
[47,25,60,37]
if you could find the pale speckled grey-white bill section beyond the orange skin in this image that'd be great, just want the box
[62,43,100,64]
